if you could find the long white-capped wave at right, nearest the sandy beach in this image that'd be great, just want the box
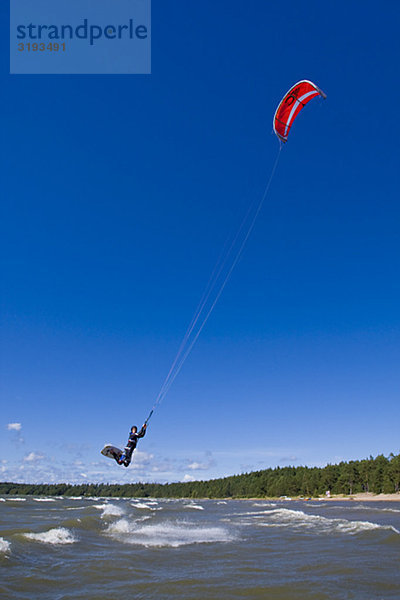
[258,508,400,535]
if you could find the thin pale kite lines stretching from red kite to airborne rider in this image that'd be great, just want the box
[145,145,282,425]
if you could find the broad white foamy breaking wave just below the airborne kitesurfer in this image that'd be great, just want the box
[107,519,234,548]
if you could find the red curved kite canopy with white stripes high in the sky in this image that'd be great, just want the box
[273,79,326,142]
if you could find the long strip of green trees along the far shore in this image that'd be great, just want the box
[0,454,400,498]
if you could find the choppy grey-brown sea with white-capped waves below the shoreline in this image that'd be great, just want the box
[0,496,400,600]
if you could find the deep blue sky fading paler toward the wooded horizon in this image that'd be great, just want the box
[0,0,400,482]
